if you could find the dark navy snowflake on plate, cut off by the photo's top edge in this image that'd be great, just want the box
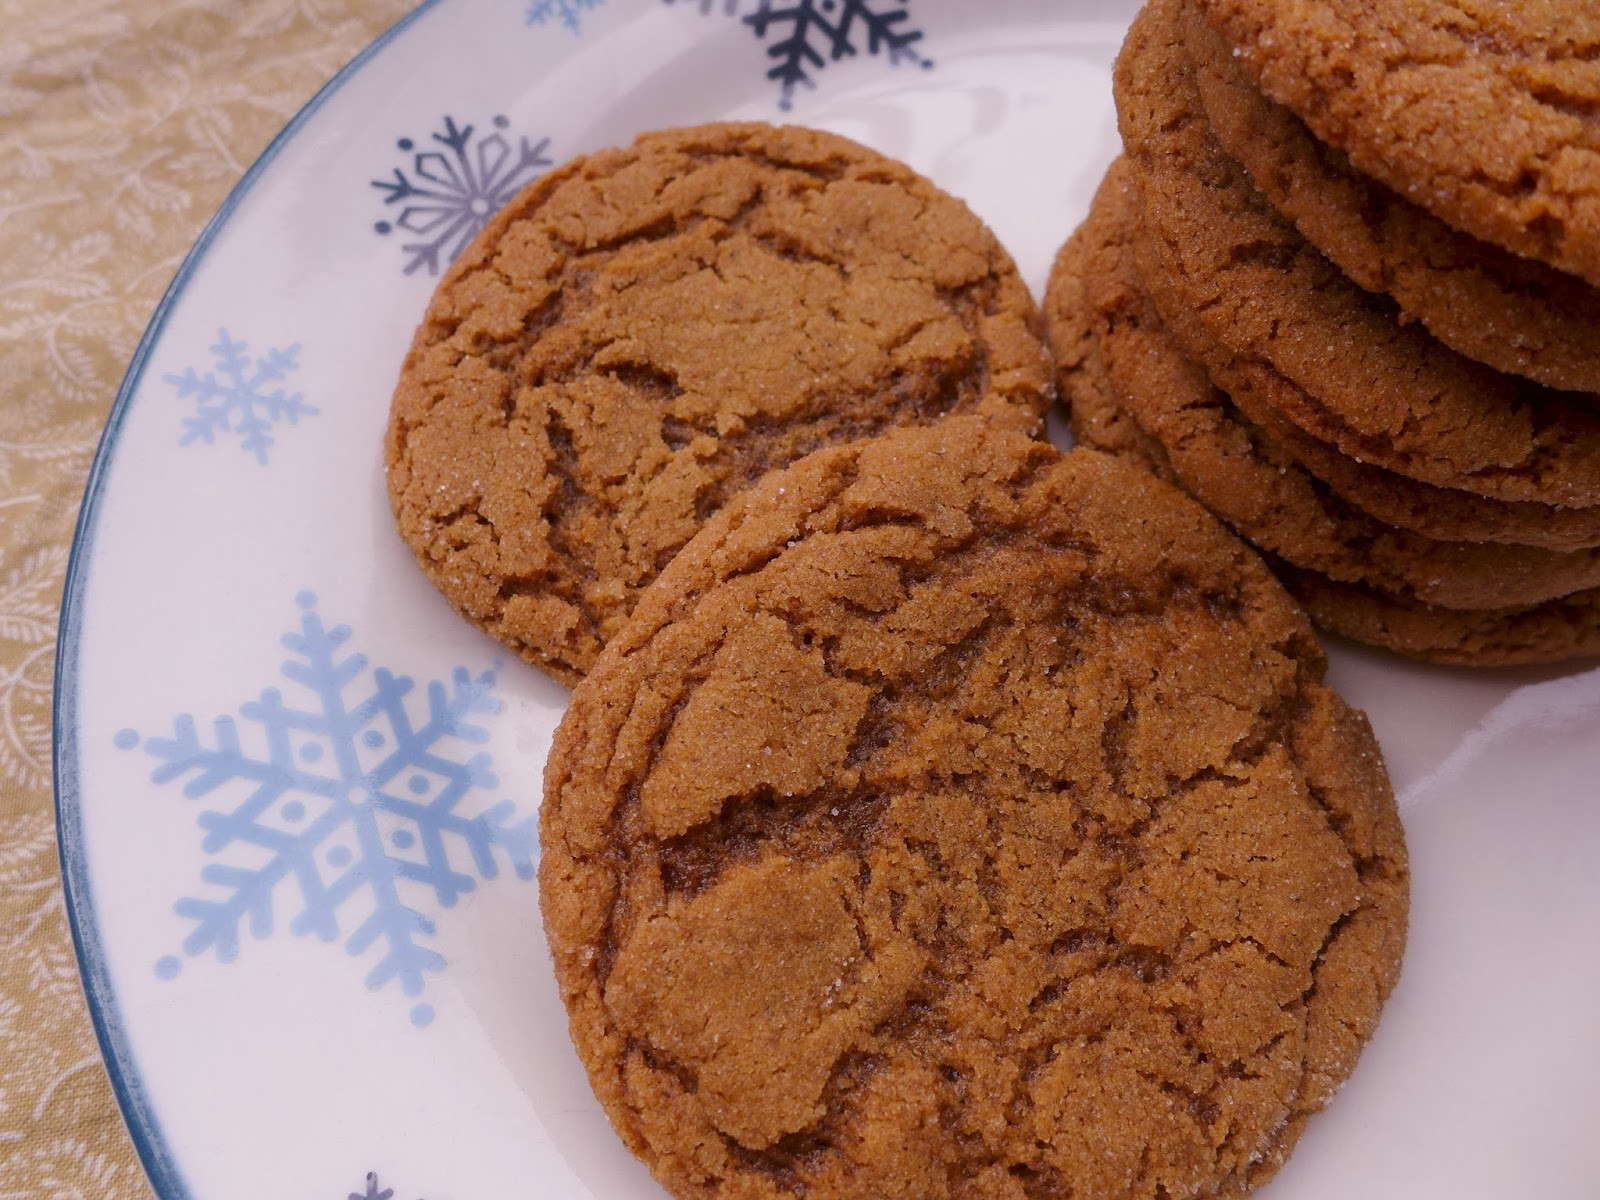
[666,0,933,112]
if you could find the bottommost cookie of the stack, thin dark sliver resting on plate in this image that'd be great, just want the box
[1278,565,1600,667]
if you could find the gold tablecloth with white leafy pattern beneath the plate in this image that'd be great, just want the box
[0,0,414,1200]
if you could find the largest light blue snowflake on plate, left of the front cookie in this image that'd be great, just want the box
[115,592,538,1026]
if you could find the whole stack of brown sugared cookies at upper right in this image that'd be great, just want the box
[1046,0,1600,664]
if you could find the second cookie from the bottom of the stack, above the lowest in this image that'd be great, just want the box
[1046,160,1600,608]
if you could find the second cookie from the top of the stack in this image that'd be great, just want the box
[1184,10,1600,392]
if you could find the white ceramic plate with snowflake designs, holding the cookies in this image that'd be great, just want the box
[56,0,1600,1200]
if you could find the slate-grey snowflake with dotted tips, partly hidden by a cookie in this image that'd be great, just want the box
[371,116,553,275]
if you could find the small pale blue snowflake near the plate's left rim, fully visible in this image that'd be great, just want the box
[162,330,317,466]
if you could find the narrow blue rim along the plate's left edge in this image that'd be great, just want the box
[51,0,440,1200]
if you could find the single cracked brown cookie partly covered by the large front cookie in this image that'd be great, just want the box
[387,125,1051,682]
